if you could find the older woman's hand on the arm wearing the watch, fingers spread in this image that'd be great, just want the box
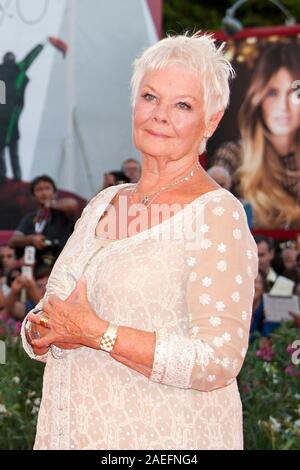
[28,277,106,349]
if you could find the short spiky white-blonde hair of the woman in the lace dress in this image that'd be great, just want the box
[131,32,235,123]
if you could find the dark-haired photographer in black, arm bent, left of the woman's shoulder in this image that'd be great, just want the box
[10,175,78,266]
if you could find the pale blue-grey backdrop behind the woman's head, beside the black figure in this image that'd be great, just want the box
[0,0,157,198]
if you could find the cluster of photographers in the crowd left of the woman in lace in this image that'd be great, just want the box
[0,175,77,331]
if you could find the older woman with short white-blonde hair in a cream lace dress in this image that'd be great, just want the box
[23,31,257,449]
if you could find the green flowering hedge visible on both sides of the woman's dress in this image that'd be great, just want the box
[0,323,300,450]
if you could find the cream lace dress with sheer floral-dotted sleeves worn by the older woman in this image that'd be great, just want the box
[22,183,257,450]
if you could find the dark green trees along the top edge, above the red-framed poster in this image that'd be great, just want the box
[163,0,300,33]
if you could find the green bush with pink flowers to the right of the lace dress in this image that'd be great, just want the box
[239,323,300,450]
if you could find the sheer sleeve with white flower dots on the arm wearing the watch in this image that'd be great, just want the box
[150,193,258,391]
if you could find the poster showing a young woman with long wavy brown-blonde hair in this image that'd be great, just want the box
[207,30,300,229]
